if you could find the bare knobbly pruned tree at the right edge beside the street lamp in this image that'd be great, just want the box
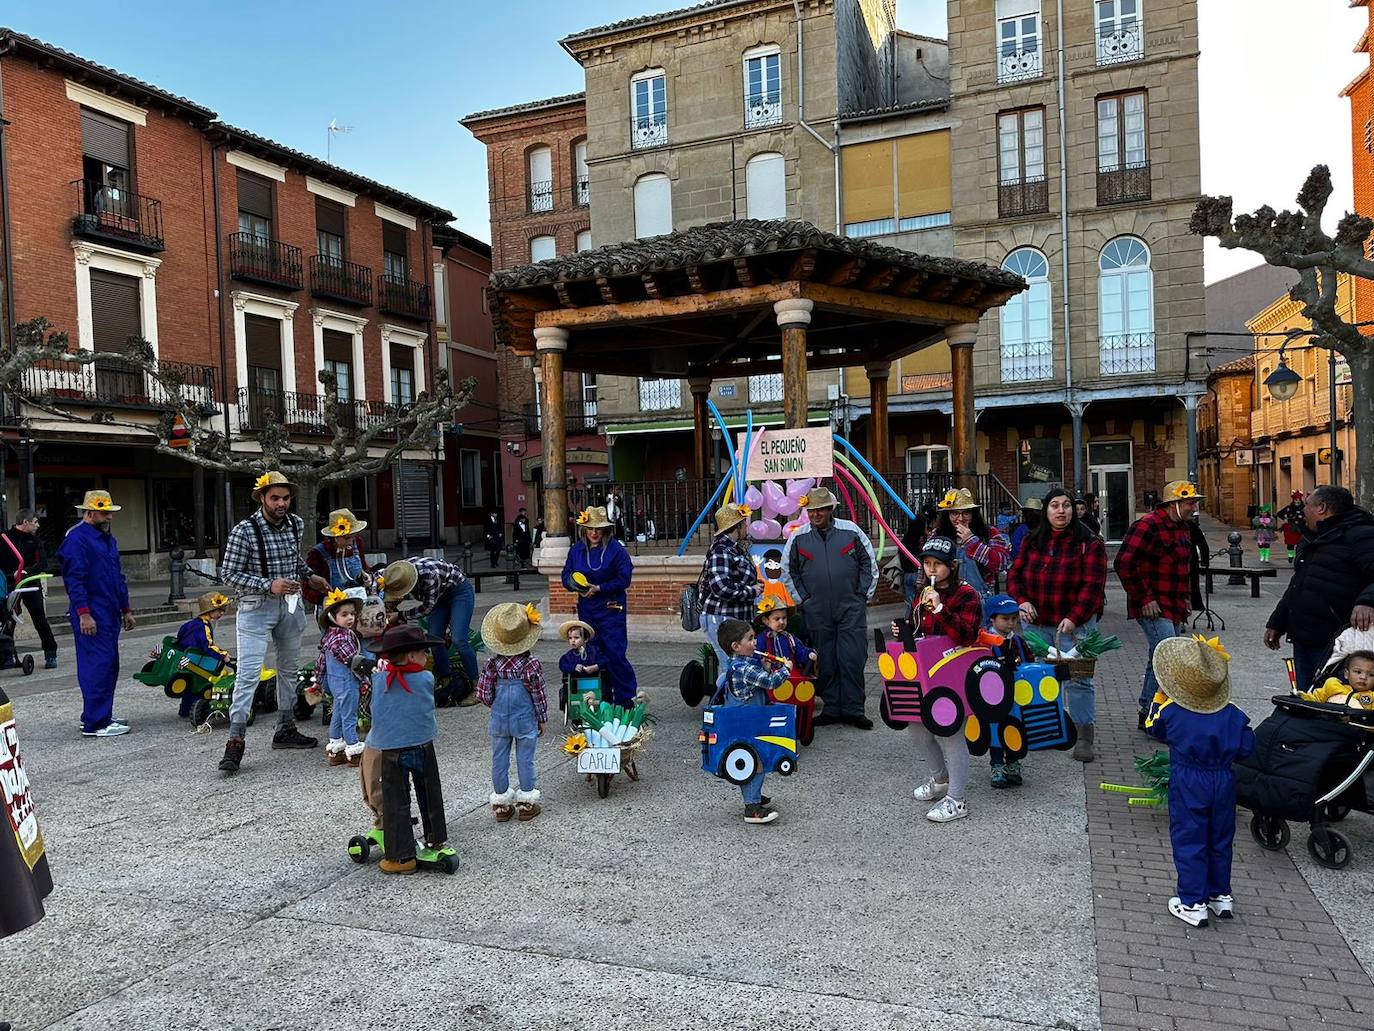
[1190,165,1374,506]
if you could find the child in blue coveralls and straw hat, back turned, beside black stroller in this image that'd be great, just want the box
[1145,636,1254,927]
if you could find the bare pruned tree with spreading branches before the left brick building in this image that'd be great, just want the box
[0,318,475,547]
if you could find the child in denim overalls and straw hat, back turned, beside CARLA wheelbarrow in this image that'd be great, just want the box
[477,602,548,823]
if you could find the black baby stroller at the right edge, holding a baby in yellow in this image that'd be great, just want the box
[1235,654,1374,870]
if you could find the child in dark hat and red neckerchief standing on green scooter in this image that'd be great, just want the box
[363,624,448,873]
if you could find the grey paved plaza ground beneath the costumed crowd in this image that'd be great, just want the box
[0,558,1374,1031]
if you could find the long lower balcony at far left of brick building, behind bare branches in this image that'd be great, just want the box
[19,355,217,411]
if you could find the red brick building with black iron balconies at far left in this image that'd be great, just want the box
[0,30,467,572]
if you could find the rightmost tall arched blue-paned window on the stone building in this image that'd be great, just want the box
[1098,236,1154,375]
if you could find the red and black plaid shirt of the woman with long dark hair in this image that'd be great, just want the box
[1007,531,1107,627]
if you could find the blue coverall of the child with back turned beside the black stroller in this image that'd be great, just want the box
[1145,693,1254,906]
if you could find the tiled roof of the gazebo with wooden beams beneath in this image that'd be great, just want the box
[491,220,1025,377]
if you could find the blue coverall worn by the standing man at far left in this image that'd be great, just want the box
[58,522,129,733]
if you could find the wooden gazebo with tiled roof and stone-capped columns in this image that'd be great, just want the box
[489,220,1025,549]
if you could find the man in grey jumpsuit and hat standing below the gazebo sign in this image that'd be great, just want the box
[782,487,878,730]
